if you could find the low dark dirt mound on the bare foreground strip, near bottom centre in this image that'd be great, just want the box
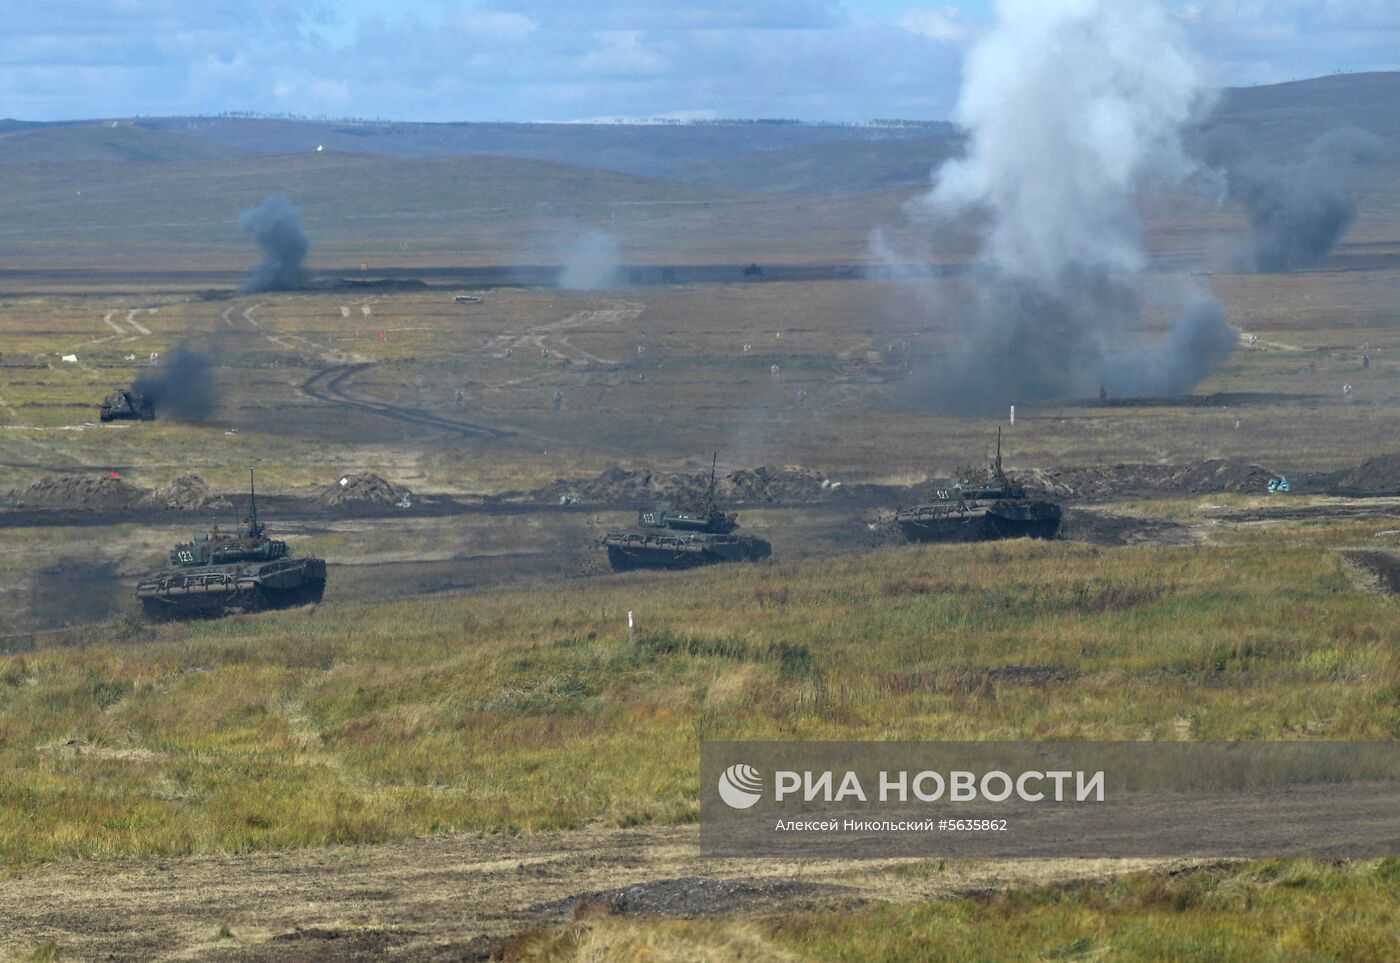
[528,876,855,918]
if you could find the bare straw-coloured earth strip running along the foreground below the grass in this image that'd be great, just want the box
[0,826,1162,960]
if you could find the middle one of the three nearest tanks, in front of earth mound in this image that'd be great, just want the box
[602,454,773,571]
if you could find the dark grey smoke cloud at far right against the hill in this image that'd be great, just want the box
[1201,127,1380,272]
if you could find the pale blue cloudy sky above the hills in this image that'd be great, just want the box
[0,0,1400,122]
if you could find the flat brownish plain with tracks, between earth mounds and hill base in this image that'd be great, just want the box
[0,272,1400,503]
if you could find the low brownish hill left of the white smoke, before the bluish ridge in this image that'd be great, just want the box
[0,151,924,271]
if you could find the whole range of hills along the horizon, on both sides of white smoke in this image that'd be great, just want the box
[0,73,1400,270]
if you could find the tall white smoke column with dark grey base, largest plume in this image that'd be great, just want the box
[911,0,1236,412]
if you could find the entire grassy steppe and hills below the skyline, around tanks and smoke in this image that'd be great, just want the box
[0,74,1400,960]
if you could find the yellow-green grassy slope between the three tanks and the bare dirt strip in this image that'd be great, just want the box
[0,521,1400,865]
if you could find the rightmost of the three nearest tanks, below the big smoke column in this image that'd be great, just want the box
[895,428,1060,542]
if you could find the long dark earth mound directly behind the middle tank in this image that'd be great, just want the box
[536,465,841,505]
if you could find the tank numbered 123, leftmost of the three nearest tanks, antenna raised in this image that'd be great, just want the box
[136,469,326,620]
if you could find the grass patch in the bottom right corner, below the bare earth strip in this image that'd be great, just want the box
[510,859,1400,963]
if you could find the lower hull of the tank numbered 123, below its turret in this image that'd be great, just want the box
[136,558,326,620]
